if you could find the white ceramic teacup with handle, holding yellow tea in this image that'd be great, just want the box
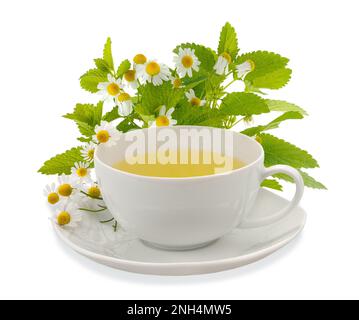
[95,126,304,250]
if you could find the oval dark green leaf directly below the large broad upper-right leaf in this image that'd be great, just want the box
[220,92,269,117]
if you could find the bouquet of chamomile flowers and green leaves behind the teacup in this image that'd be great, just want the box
[39,23,325,230]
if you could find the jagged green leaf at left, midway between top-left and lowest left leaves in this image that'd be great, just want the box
[64,101,103,127]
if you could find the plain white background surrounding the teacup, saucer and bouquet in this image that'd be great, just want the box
[0,0,359,299]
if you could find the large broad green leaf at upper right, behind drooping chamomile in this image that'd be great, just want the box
[237,51,292,89]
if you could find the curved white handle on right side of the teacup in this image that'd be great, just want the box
[239,165,304,228]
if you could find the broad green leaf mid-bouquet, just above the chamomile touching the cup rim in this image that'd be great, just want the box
[141,82,183,114]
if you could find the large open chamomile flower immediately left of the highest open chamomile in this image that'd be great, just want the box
[136,60,171,86]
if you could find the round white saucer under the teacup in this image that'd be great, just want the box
[54,189,306,275]
